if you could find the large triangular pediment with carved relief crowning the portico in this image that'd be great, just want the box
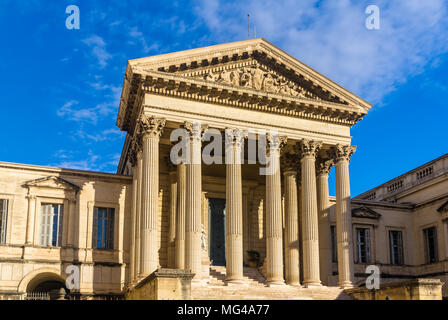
[129,38,371,111]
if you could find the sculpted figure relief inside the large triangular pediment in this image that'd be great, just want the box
[197,64,316,98]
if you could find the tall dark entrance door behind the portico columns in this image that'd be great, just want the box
[209,198,226,266]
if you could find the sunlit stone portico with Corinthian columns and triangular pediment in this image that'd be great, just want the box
[117,39,370,288]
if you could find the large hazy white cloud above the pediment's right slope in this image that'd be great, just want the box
[195,0,448,103]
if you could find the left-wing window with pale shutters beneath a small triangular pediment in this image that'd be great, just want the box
[40,203,64,247]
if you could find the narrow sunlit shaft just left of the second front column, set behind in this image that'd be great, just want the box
[174,163,187,269]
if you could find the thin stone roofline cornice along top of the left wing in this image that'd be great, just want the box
[0,161,132,181]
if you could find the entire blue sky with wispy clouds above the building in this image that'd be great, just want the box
[0,0,448,195]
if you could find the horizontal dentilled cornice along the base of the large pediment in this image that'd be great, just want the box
[117,71,366,131]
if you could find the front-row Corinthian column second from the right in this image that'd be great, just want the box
[298,139,322,287]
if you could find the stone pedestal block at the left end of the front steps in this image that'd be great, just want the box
[125,269,194,300]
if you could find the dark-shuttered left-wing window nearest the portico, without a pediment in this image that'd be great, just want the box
[92,207,115,249]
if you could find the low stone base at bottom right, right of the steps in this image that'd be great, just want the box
[345,278,443,300]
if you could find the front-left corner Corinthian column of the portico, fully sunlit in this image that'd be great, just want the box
[139,114,165,276]
